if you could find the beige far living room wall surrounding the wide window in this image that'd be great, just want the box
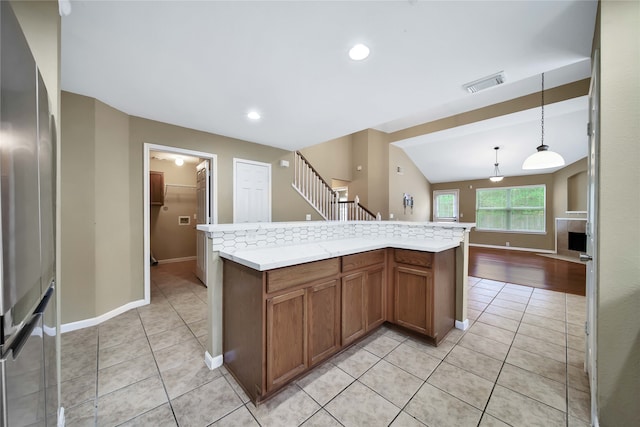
[431,174,555,251]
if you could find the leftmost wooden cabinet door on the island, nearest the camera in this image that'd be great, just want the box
[266,289,307,392]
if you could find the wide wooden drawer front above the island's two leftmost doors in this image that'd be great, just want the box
[267,258,340,293]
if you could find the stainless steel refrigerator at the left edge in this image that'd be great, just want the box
[0,1,58,427]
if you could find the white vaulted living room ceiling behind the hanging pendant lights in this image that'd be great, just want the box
[395,96,589,183]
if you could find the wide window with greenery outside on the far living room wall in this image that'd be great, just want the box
[476,185,546,233]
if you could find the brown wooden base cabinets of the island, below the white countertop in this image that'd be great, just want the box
[222,249,455,404]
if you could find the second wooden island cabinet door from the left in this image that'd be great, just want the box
[307,279,340,366]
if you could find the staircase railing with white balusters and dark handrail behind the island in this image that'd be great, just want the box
[291,151,376,221]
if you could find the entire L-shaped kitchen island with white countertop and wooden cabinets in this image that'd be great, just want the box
[198,222,472,403]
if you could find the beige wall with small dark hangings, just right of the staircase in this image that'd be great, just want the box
[383,144,431,221]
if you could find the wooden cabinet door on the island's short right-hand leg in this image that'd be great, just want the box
[394,266,433,336]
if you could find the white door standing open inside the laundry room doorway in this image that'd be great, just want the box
[196,160,211,286]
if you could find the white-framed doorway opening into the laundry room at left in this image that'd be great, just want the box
[143,143,218,304]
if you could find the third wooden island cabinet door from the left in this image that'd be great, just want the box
[342,272,366,346]
